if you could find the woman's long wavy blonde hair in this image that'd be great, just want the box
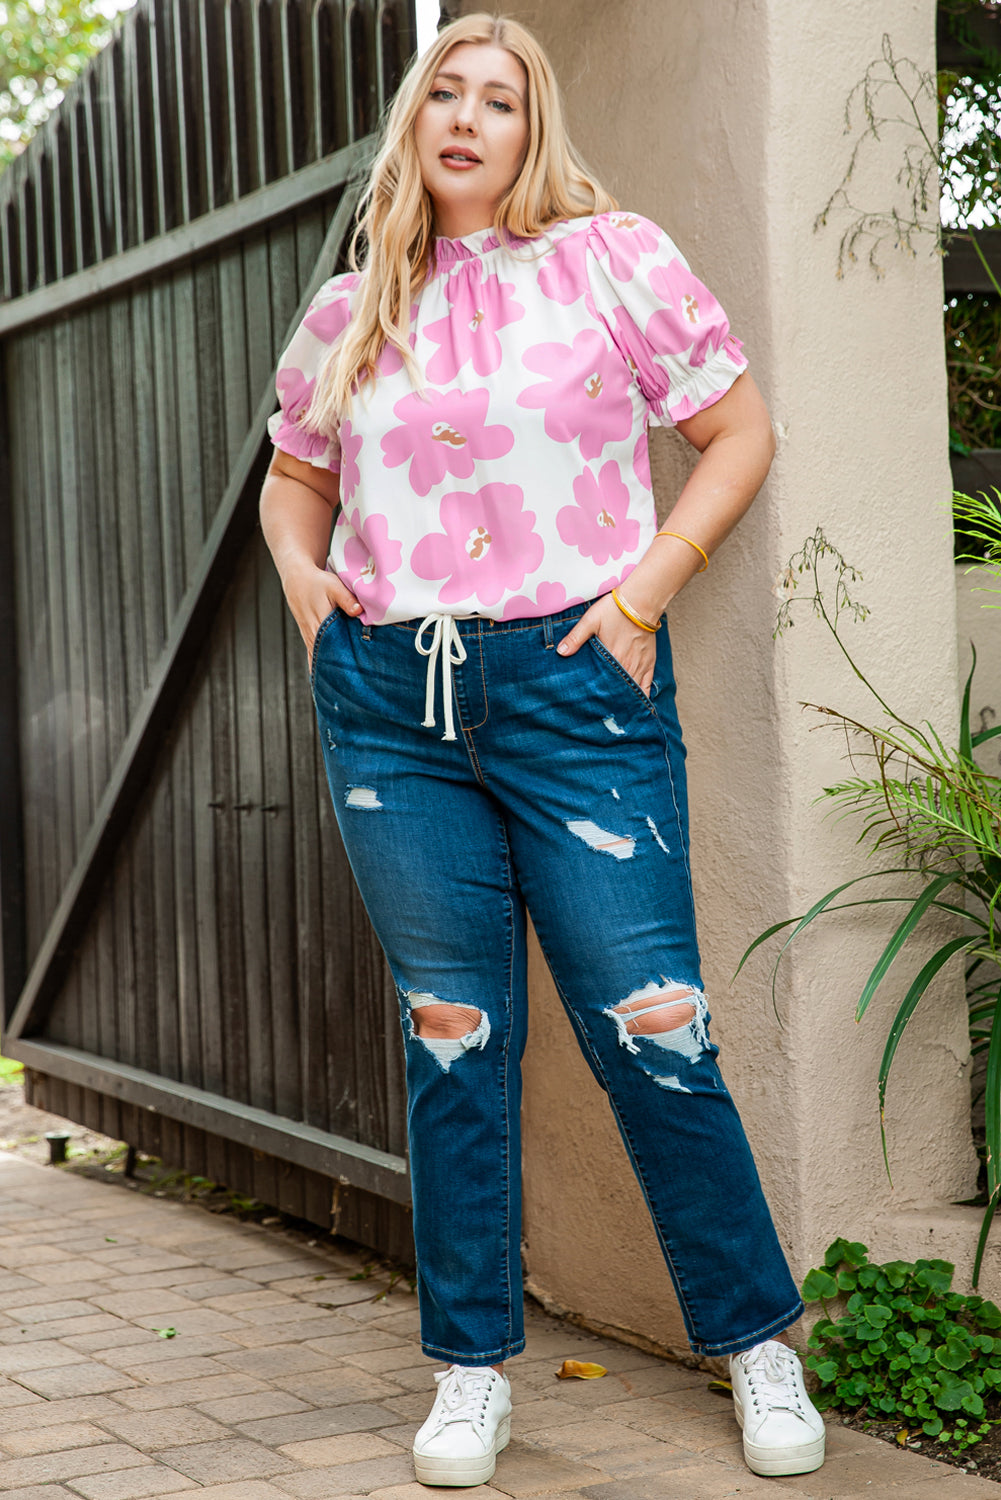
[305,14,618,432]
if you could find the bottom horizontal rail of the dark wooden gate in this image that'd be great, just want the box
[9,1038,410,1203]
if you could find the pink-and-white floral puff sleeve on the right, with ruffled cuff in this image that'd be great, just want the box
[585,213,747,426]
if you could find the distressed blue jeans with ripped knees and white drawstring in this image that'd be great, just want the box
[312,605,803,1365]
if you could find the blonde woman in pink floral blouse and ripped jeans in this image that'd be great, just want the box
[261,15,824,1485]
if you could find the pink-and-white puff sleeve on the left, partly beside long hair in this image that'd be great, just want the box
[267,275,357,474]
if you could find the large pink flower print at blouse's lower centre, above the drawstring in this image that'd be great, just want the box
[410,483,543,605]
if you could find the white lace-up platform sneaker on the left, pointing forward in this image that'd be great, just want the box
[414,1365,510,1485]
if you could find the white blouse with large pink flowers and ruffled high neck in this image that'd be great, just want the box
[269,212,746,624]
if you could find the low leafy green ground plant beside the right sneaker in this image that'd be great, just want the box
[801,1239,1001,1457]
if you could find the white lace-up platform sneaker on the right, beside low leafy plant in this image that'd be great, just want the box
[729,1338,825,1478]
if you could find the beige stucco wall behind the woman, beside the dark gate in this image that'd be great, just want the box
[464,0,975,1349]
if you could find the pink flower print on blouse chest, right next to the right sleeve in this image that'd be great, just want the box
[518,329,633,459]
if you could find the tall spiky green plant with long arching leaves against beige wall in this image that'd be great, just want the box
[737,495,1001,1286]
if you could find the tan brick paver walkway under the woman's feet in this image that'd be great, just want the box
[0,1152,1001,1500]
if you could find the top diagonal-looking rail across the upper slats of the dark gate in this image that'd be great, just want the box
[0,137,374,335]
